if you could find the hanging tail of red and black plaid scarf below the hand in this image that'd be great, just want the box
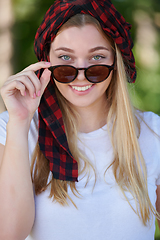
[38,80,78,181]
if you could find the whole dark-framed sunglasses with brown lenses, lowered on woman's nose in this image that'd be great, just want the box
[48,63,114,83]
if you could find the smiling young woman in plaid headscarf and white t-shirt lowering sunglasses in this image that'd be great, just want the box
[0,0,160,240]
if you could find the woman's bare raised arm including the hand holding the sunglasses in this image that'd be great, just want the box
[0,62,50,240]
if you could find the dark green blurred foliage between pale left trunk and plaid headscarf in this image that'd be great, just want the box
[12,0,53,72]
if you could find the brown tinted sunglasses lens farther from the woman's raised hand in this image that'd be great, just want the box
[86,66,109,83]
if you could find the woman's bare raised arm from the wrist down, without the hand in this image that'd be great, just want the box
[0,123,35,240]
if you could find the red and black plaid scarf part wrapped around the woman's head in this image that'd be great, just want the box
[35,0,136,82]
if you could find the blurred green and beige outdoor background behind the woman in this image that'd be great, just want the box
[0,0,160,240]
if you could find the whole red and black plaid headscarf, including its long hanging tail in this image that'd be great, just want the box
[34,0,136,181]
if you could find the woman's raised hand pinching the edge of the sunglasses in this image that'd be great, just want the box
[1,62,51,121]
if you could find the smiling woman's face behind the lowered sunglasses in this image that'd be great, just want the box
[50,25,114,110]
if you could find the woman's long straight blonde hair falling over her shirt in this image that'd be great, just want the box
[31,14,159,225]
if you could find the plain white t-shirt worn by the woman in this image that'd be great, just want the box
[0,112,160,240]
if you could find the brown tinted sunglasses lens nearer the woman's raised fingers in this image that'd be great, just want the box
[53,66,76,83]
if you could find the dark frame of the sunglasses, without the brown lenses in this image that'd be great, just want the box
[48,61,115,84]
